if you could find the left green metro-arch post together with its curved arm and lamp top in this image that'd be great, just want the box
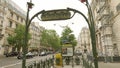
[22,0,44,68]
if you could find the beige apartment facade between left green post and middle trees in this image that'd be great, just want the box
[29,22,43,51]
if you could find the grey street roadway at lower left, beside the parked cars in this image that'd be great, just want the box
[0,55,52,68]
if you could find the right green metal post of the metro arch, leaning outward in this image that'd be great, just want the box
[80,0,98,68]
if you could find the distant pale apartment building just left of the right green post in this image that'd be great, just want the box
[78,27,92,54]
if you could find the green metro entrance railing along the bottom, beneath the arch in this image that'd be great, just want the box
[26,56,95,68]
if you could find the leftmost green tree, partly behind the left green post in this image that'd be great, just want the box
[7,25,31,52]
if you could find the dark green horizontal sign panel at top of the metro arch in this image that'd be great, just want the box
[41,9,71,21]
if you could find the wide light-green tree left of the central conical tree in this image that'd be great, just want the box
[40,30,60,49]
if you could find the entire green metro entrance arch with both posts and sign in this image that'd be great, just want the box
[22,0,98,68]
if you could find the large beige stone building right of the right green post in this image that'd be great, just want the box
[91,0,120,56]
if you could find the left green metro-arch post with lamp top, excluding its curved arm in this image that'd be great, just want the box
[22,1,33,68]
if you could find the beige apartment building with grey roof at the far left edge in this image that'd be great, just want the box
[0,0,26,54]
